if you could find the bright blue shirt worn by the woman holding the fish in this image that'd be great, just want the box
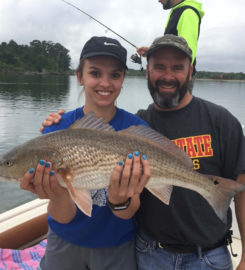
[43,108,147,248]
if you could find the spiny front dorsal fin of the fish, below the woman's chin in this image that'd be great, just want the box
[69,112,115,131]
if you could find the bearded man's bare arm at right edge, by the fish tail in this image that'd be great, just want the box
[235,174,245,270]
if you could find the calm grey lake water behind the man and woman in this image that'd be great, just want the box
[0,74,245,236]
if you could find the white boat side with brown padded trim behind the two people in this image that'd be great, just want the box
[0,199,242,270]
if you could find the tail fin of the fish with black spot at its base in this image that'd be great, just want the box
[206,175,245,224]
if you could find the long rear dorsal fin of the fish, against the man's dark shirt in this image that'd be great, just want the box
[118,125,193,168]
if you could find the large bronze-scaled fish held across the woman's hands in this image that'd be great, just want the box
[0,113,245,222]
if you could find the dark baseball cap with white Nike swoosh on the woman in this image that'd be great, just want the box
[80,36,128,69]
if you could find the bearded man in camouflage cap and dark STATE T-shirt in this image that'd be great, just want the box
[136,34,245,270]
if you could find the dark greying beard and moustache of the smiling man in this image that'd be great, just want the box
[148,73,189,109]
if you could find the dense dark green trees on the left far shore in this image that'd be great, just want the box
[0,40,71,72]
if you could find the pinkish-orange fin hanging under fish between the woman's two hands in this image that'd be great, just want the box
[57,168,93,217]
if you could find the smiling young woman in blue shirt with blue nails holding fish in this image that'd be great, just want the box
[21,37,150,270]
